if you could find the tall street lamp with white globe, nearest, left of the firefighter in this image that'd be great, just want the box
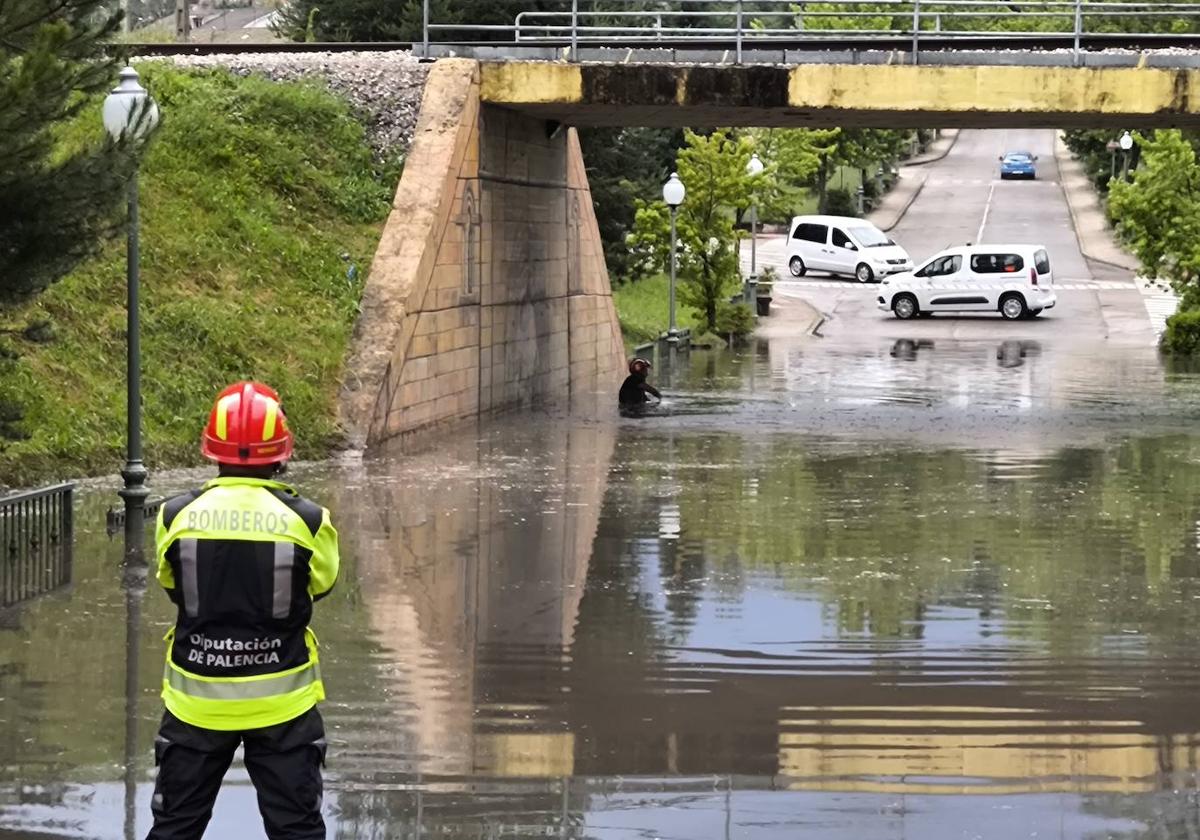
[103,67,158,564]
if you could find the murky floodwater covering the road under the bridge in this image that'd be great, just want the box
[0,341,1200,840]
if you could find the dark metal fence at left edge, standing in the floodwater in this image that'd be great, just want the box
[0,484,74,608]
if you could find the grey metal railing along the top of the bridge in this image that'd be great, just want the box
[424,0,1200,64]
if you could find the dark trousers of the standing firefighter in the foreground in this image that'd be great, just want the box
[146,708,325,840]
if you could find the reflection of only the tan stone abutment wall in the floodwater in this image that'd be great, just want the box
[328,427,613,786]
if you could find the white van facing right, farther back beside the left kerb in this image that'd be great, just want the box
[787,216,912,283]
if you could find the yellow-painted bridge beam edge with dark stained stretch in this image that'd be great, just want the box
[480,61,1200,115]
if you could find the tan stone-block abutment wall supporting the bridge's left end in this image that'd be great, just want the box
[342,60,623,448]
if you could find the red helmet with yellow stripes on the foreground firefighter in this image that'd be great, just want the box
[200,382,293,467]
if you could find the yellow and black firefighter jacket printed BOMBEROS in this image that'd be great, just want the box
[157,476,338,730]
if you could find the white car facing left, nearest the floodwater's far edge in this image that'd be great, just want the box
[878,245,1058,320]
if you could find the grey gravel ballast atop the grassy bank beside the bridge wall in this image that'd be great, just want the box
[164,52,428,157]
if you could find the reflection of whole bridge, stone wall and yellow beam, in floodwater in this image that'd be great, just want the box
[328,420,1200,810]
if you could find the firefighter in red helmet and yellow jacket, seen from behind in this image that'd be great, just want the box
[148,382,338,840]
